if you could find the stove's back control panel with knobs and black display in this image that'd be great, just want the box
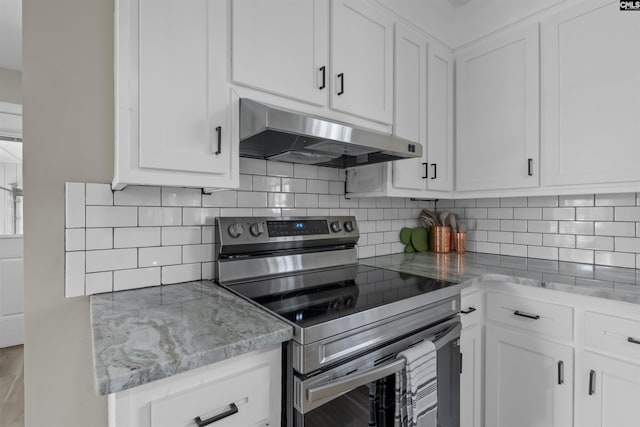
[216,216,359,252]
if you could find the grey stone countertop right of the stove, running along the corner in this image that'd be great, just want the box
[360,252,640,304]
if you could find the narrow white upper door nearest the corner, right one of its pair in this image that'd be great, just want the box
[427,43,453,191]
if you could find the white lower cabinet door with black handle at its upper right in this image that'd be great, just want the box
[485,325,573,427]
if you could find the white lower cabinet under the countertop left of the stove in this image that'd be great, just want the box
[109,345,282,427]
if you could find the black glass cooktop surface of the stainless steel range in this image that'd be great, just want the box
[222,265,456,328]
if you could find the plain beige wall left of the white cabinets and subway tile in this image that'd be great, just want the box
[22,0,114,427]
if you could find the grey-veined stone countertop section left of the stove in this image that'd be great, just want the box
[90,281,293,395]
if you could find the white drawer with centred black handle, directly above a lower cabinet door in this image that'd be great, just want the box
[487,292,573,341]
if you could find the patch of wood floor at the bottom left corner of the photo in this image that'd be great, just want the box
[0,345,24,427]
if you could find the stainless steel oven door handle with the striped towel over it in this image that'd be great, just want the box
[307,322,462,402]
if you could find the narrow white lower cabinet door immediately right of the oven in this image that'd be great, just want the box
[460,325,482,427]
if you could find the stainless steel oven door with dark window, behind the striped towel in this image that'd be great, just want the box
[287,316,461,427]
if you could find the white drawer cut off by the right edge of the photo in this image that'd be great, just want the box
[584,312,640,360]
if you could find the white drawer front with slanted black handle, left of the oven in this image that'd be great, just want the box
[149,364,272,427]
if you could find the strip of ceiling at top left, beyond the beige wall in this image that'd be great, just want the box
[0,0,22,71]
